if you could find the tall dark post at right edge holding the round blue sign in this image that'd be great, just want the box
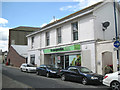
[113,0,119,71]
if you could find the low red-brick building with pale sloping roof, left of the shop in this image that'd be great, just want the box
[7,45,27,67]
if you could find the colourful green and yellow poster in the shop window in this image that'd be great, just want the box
[69,55,81,66]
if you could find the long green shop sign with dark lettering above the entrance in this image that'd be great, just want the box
[44,44,80,54]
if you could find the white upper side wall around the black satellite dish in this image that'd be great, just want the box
[93,2,115,40]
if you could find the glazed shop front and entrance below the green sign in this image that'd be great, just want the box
[52,54,81,69]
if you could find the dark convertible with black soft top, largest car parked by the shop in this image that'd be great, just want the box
[60,66,103,85]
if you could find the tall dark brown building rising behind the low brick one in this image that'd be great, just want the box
[8,26,40,47]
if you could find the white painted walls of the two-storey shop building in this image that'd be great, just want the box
[28,3,120,69]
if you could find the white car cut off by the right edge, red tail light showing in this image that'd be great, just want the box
[103,71,120,90]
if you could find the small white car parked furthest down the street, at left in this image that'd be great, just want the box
[20,63,36,72]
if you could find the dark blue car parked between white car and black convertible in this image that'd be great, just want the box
[36,65,60,77]
